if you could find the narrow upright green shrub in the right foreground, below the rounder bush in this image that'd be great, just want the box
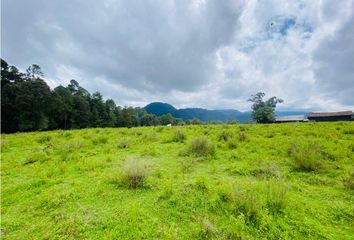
[267,180,288,213]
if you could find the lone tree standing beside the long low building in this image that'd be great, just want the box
[248,92,283,123]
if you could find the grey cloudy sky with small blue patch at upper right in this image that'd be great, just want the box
[1,0,354,110]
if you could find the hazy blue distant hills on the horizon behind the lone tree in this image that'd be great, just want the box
[144,102,306,123]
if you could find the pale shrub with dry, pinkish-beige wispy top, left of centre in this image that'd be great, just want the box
[122,158,150,189]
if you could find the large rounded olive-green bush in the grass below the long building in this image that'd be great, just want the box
[288,142,326,172]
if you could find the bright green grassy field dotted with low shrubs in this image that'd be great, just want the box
[1,122,354,239]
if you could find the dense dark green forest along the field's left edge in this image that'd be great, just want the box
[1,59,183,133]
